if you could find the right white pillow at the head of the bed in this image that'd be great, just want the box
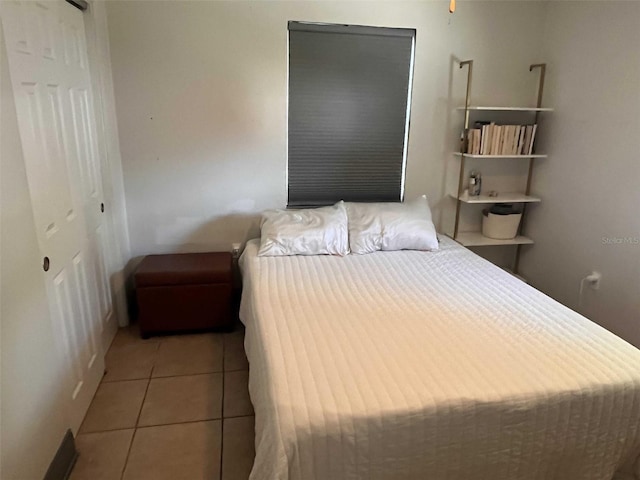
[346,195,438,254]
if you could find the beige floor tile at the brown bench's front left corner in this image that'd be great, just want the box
[103,342,159,382]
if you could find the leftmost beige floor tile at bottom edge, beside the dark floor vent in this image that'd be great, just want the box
[69,429,133,480]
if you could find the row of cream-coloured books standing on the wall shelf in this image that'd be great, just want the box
[466,122,538,155]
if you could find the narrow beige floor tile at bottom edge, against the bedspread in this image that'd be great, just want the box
[222,417,255,480]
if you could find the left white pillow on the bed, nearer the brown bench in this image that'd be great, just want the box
[258,201,349,256]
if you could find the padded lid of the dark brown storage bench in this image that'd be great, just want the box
[134,252,233,287]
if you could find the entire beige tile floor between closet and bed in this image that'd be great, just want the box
[71,326,254,480]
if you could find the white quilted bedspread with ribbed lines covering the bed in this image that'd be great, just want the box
[241,239,640,480]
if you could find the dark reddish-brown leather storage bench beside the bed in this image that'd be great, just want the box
[134,252,233,338]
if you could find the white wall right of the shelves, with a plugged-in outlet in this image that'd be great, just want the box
[521,1,640,347]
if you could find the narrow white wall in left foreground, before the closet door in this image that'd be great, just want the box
[0,26,68,480]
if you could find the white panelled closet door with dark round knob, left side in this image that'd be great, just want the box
[0,0,111,432]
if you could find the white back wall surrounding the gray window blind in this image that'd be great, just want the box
[108,0,545,256]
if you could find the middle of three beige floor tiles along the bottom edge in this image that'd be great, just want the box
[123,420,222,480]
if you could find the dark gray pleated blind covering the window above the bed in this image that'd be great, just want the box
[288,22,415,206]
